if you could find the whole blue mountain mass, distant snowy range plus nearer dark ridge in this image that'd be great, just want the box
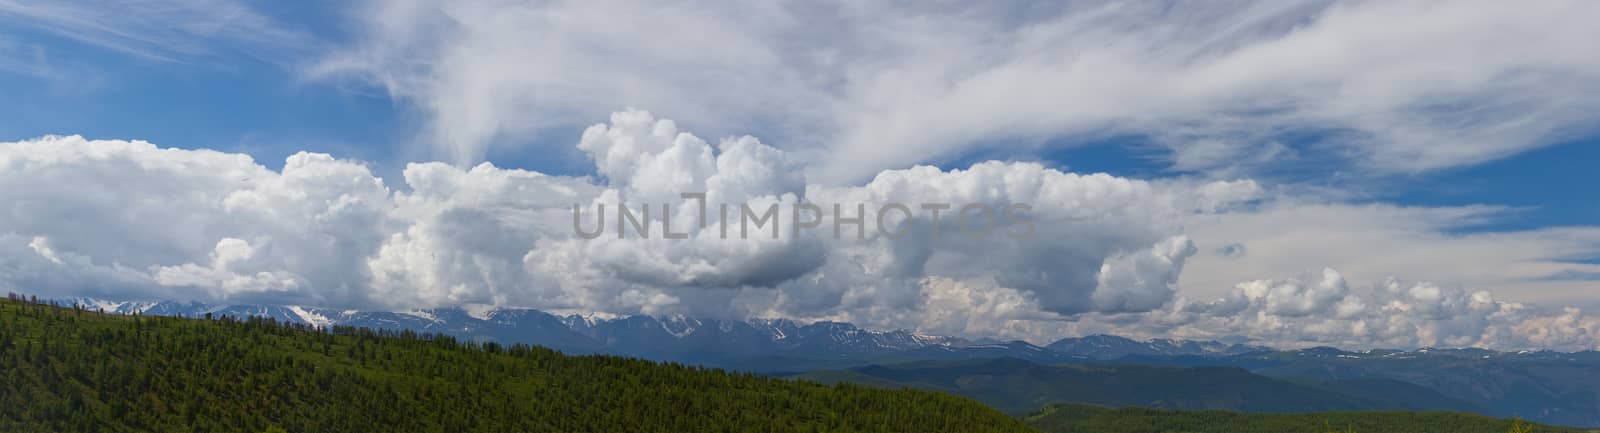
[46,299,1600,427]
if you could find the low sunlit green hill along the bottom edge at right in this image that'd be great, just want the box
[1026,404,1584,433]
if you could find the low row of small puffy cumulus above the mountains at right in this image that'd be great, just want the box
[1141,268,1600,350]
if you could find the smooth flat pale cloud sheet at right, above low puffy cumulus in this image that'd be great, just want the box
[1181,202,1600,305]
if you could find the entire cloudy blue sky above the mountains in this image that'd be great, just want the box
[0,0,1600,350]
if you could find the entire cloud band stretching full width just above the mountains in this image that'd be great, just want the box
[0,112,1600,348]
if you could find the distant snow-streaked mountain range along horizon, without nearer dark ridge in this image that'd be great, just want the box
[56,297,1600,367]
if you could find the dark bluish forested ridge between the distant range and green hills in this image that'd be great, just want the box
[798,358,1472,415]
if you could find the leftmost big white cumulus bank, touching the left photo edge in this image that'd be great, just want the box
[0,136,392,304]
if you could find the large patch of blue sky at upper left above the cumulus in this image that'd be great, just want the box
[0,10,396,171]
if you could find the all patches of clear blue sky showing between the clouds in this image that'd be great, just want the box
[0,15,1600,230]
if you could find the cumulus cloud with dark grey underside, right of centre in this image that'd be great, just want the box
[810,161,1259,315]
